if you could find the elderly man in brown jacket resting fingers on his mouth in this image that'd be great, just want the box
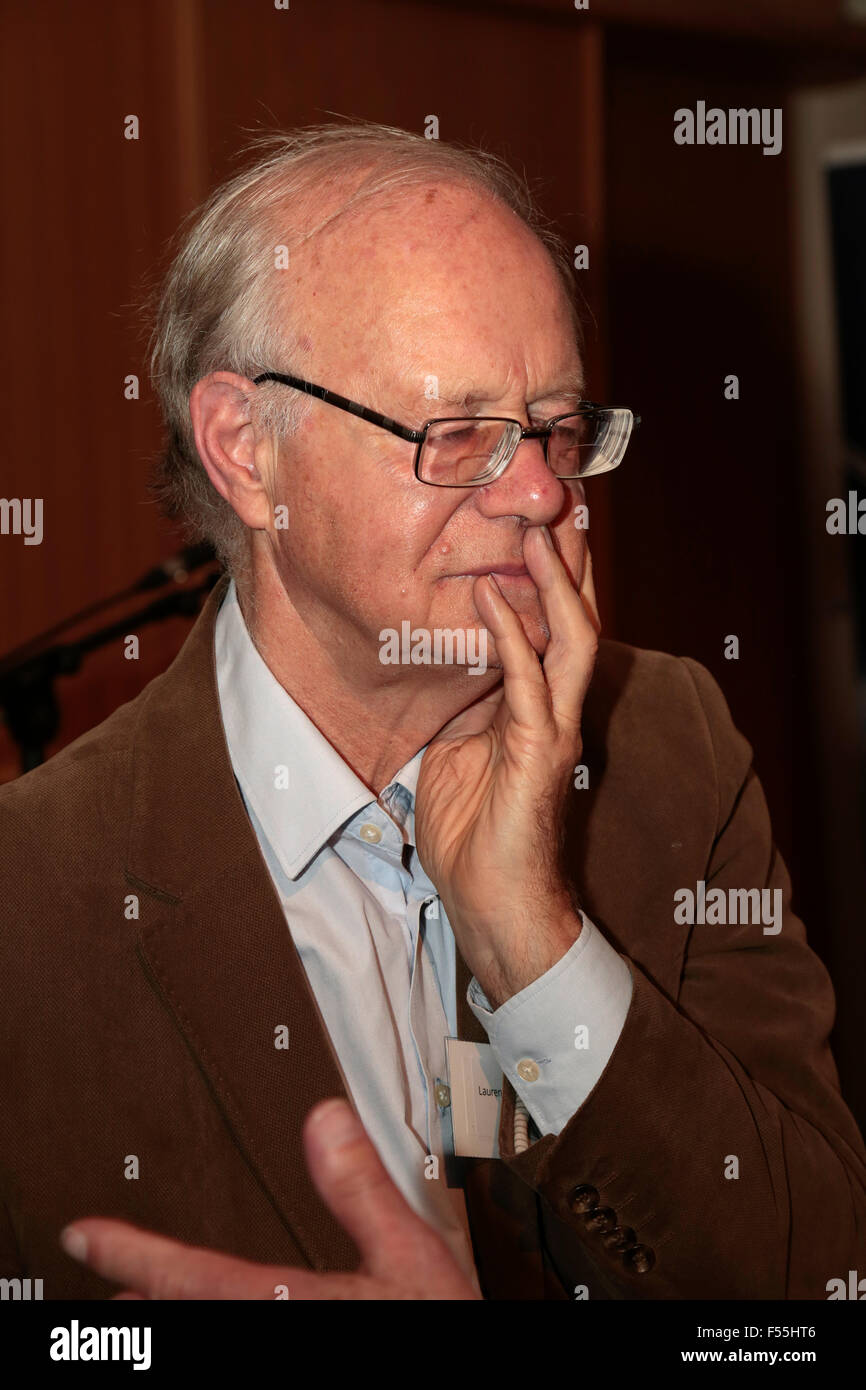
[0,126,866,1298]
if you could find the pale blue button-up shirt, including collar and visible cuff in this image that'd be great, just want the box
[214,582,632,1283]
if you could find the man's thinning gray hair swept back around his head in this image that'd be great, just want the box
[150,122,580,578]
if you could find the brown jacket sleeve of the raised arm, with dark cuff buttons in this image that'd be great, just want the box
[499,659,866,1300]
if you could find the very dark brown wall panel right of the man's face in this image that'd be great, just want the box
[606,29,866,1118]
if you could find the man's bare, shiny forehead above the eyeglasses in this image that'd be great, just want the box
[293,183,585,411]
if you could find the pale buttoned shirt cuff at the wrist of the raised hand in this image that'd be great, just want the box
[466,912,634,1134]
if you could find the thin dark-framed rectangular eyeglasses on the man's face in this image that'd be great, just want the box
[253,371,641,488]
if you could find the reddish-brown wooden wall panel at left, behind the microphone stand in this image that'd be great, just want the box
[0,0,206,777]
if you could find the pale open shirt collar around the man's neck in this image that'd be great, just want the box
[214,580,425,878]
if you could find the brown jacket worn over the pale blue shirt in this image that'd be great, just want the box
[0,581,866,1300]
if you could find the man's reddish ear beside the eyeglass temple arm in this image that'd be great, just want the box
[189,371,272,530]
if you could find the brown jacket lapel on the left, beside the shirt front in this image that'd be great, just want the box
[126,580,359,1269]
